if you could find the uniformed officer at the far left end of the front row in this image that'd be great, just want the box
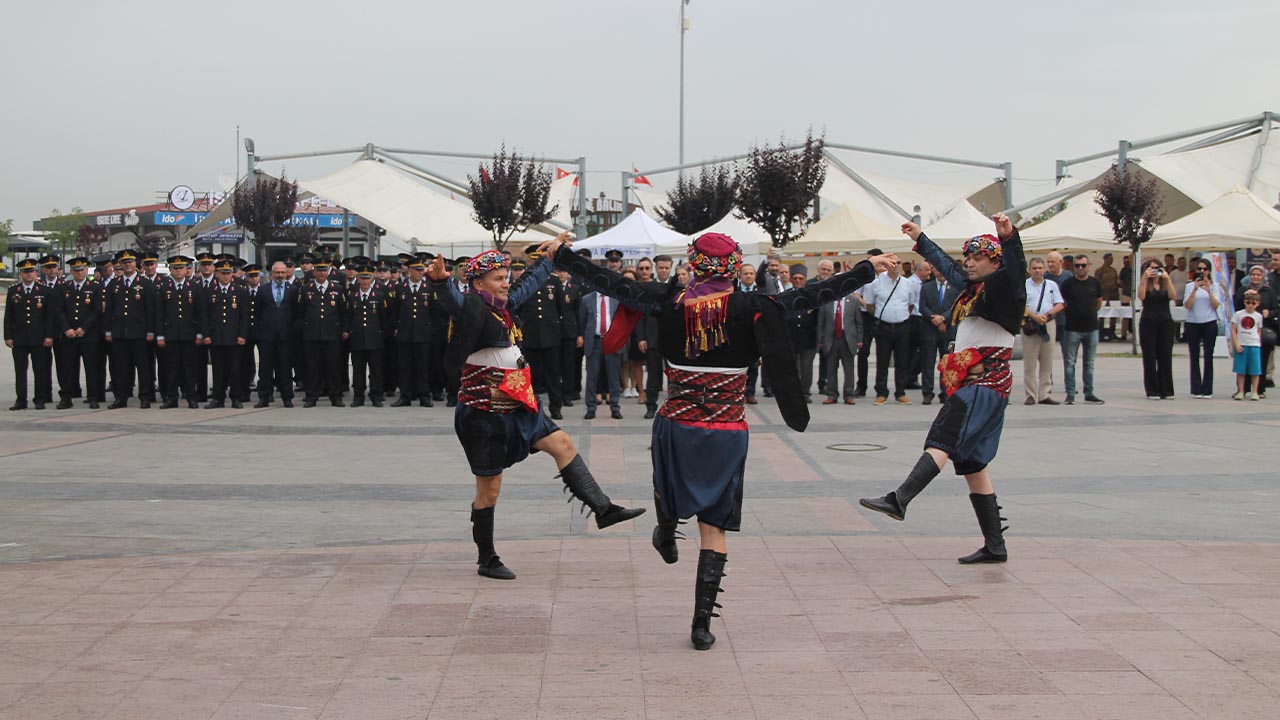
[4,258,56,410]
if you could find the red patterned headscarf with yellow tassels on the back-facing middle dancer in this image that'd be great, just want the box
[676,232,742,359]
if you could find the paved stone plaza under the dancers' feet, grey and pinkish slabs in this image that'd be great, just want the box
[0,346,1280,720]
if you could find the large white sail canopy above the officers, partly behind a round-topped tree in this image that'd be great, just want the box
[298,160,554,256]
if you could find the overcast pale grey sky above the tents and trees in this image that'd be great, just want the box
[0,0,1280,229]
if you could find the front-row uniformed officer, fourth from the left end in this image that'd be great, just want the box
[156,255,206,410]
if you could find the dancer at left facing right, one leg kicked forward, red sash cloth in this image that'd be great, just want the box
[428,233,644,580]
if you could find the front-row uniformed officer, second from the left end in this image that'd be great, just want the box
[54,258,102,410]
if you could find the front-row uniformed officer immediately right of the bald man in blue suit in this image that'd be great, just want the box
[298,258,347,407]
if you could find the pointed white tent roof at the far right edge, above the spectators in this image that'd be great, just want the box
[1143,186,1280,251]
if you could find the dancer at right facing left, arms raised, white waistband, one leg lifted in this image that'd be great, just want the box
[860,214,1027,565]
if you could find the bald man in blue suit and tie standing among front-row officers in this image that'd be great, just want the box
[253,260,298,407]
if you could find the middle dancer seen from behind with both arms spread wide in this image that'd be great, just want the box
[556,233,897,650]
